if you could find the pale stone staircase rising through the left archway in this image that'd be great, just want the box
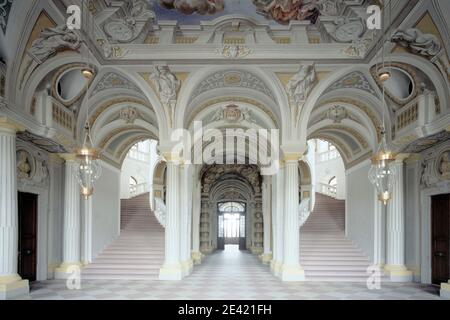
[81,193,164,280]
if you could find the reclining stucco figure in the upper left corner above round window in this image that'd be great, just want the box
[28,24,81,64]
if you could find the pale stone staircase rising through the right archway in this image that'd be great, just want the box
[300,193,371,282]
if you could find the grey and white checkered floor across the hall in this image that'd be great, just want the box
[15,248,439,300]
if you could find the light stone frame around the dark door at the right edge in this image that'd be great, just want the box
[420,183,450,284]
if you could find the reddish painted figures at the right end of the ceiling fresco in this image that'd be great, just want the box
[253,0,320,24]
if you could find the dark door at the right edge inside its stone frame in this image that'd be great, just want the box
[431,194,450,285]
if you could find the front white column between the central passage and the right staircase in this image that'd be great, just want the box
[281,153,305,281]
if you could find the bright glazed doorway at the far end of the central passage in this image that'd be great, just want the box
[217,201,246,250]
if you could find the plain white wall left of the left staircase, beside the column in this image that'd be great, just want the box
[92,162,120,257]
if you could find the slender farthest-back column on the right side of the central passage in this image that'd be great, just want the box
[260,176,272,264]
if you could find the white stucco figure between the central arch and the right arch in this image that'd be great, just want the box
[286,65,316,105]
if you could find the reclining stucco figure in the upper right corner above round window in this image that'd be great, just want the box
[391,28,441,57]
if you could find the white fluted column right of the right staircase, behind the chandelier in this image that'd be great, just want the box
[384,154,412,282]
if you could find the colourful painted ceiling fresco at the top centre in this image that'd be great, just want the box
[149,0,320,25]
